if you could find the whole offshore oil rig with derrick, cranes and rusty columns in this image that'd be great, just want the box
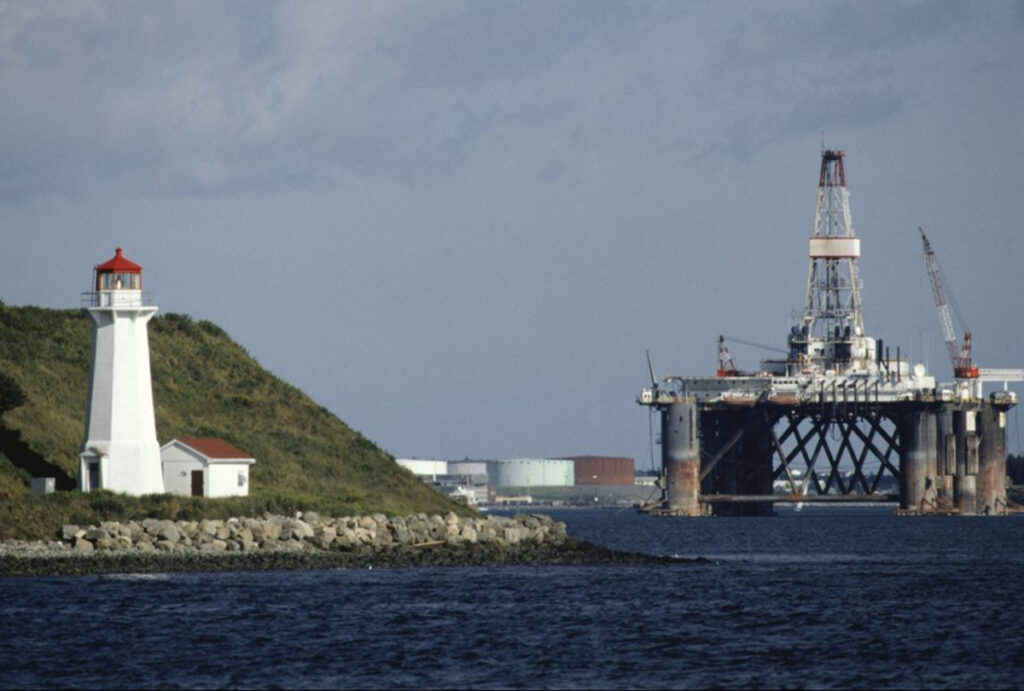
[637,150,1024,516]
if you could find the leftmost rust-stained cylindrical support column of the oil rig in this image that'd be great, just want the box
[662,397,700,516]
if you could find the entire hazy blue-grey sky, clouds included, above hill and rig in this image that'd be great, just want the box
[0,0,1024,467]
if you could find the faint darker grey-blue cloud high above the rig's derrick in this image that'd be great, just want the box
[694,2,971,161]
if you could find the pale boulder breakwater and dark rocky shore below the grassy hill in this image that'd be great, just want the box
[0,512,679,575]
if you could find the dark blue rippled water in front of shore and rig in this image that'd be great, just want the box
[0,508,1024,688]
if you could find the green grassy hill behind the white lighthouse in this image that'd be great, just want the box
[0,303,465,537]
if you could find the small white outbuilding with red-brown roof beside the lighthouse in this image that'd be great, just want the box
[160,437,256,496]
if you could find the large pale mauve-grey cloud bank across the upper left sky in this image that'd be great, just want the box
[0,2,641,198]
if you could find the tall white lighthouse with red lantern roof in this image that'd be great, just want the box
[79,247,164,494]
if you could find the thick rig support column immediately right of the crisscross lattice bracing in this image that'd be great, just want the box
[899,409,938,512]
